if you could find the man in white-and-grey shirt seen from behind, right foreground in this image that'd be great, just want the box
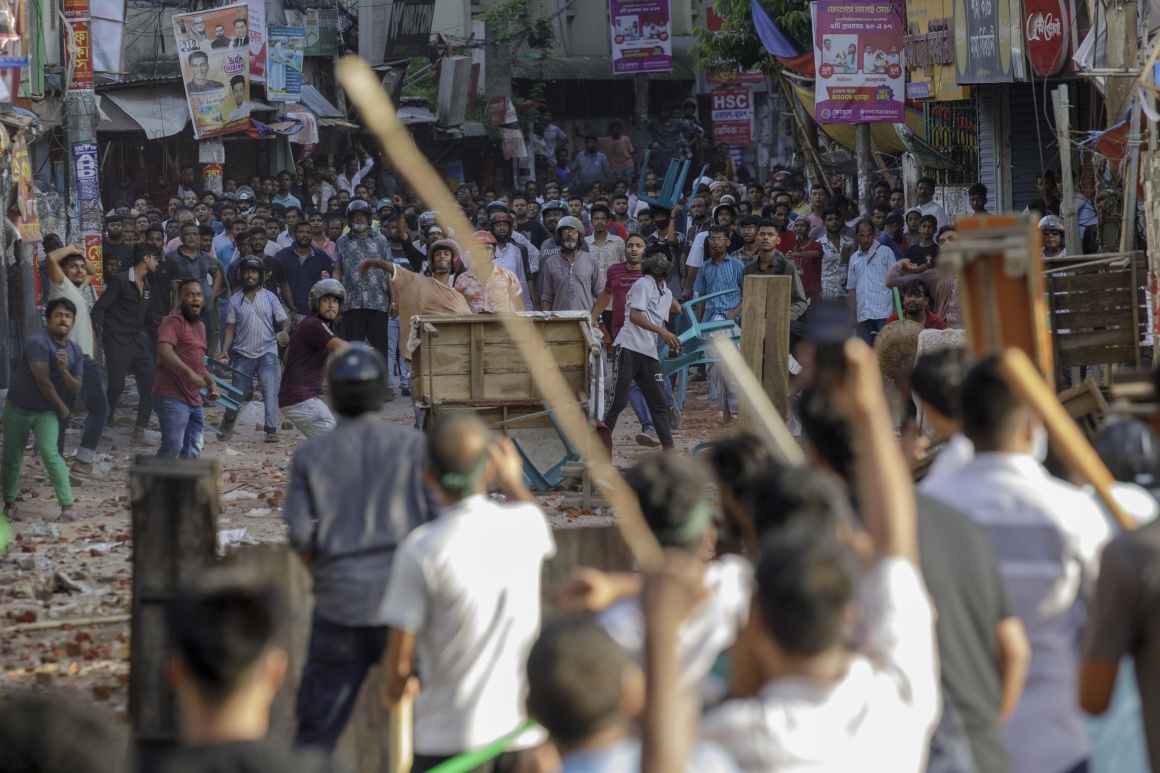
[923,357,1111,773]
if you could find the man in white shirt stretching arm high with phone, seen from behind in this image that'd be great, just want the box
[663,339,938,773]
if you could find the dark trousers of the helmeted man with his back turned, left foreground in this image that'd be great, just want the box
[295,612,389,747]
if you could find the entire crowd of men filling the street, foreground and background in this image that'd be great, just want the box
[0,129,1160,773]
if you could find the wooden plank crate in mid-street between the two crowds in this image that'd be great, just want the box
[412,315,593,409]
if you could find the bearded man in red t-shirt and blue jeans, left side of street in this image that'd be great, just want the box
[153,277,218,458]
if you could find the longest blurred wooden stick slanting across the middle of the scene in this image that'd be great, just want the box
[338,57,662,568]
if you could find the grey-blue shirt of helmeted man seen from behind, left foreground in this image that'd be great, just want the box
[283,414,438,626]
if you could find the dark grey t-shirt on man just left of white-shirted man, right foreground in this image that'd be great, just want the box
[918,494,1014,773]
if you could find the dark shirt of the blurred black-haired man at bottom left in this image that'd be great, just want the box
[140,739,345,773]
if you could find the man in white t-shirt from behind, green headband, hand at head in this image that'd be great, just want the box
[382,414,556,773]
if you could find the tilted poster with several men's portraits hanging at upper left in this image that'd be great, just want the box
[173,5,251,139]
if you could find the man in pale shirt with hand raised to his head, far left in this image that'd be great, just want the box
[44,244,109,478]
